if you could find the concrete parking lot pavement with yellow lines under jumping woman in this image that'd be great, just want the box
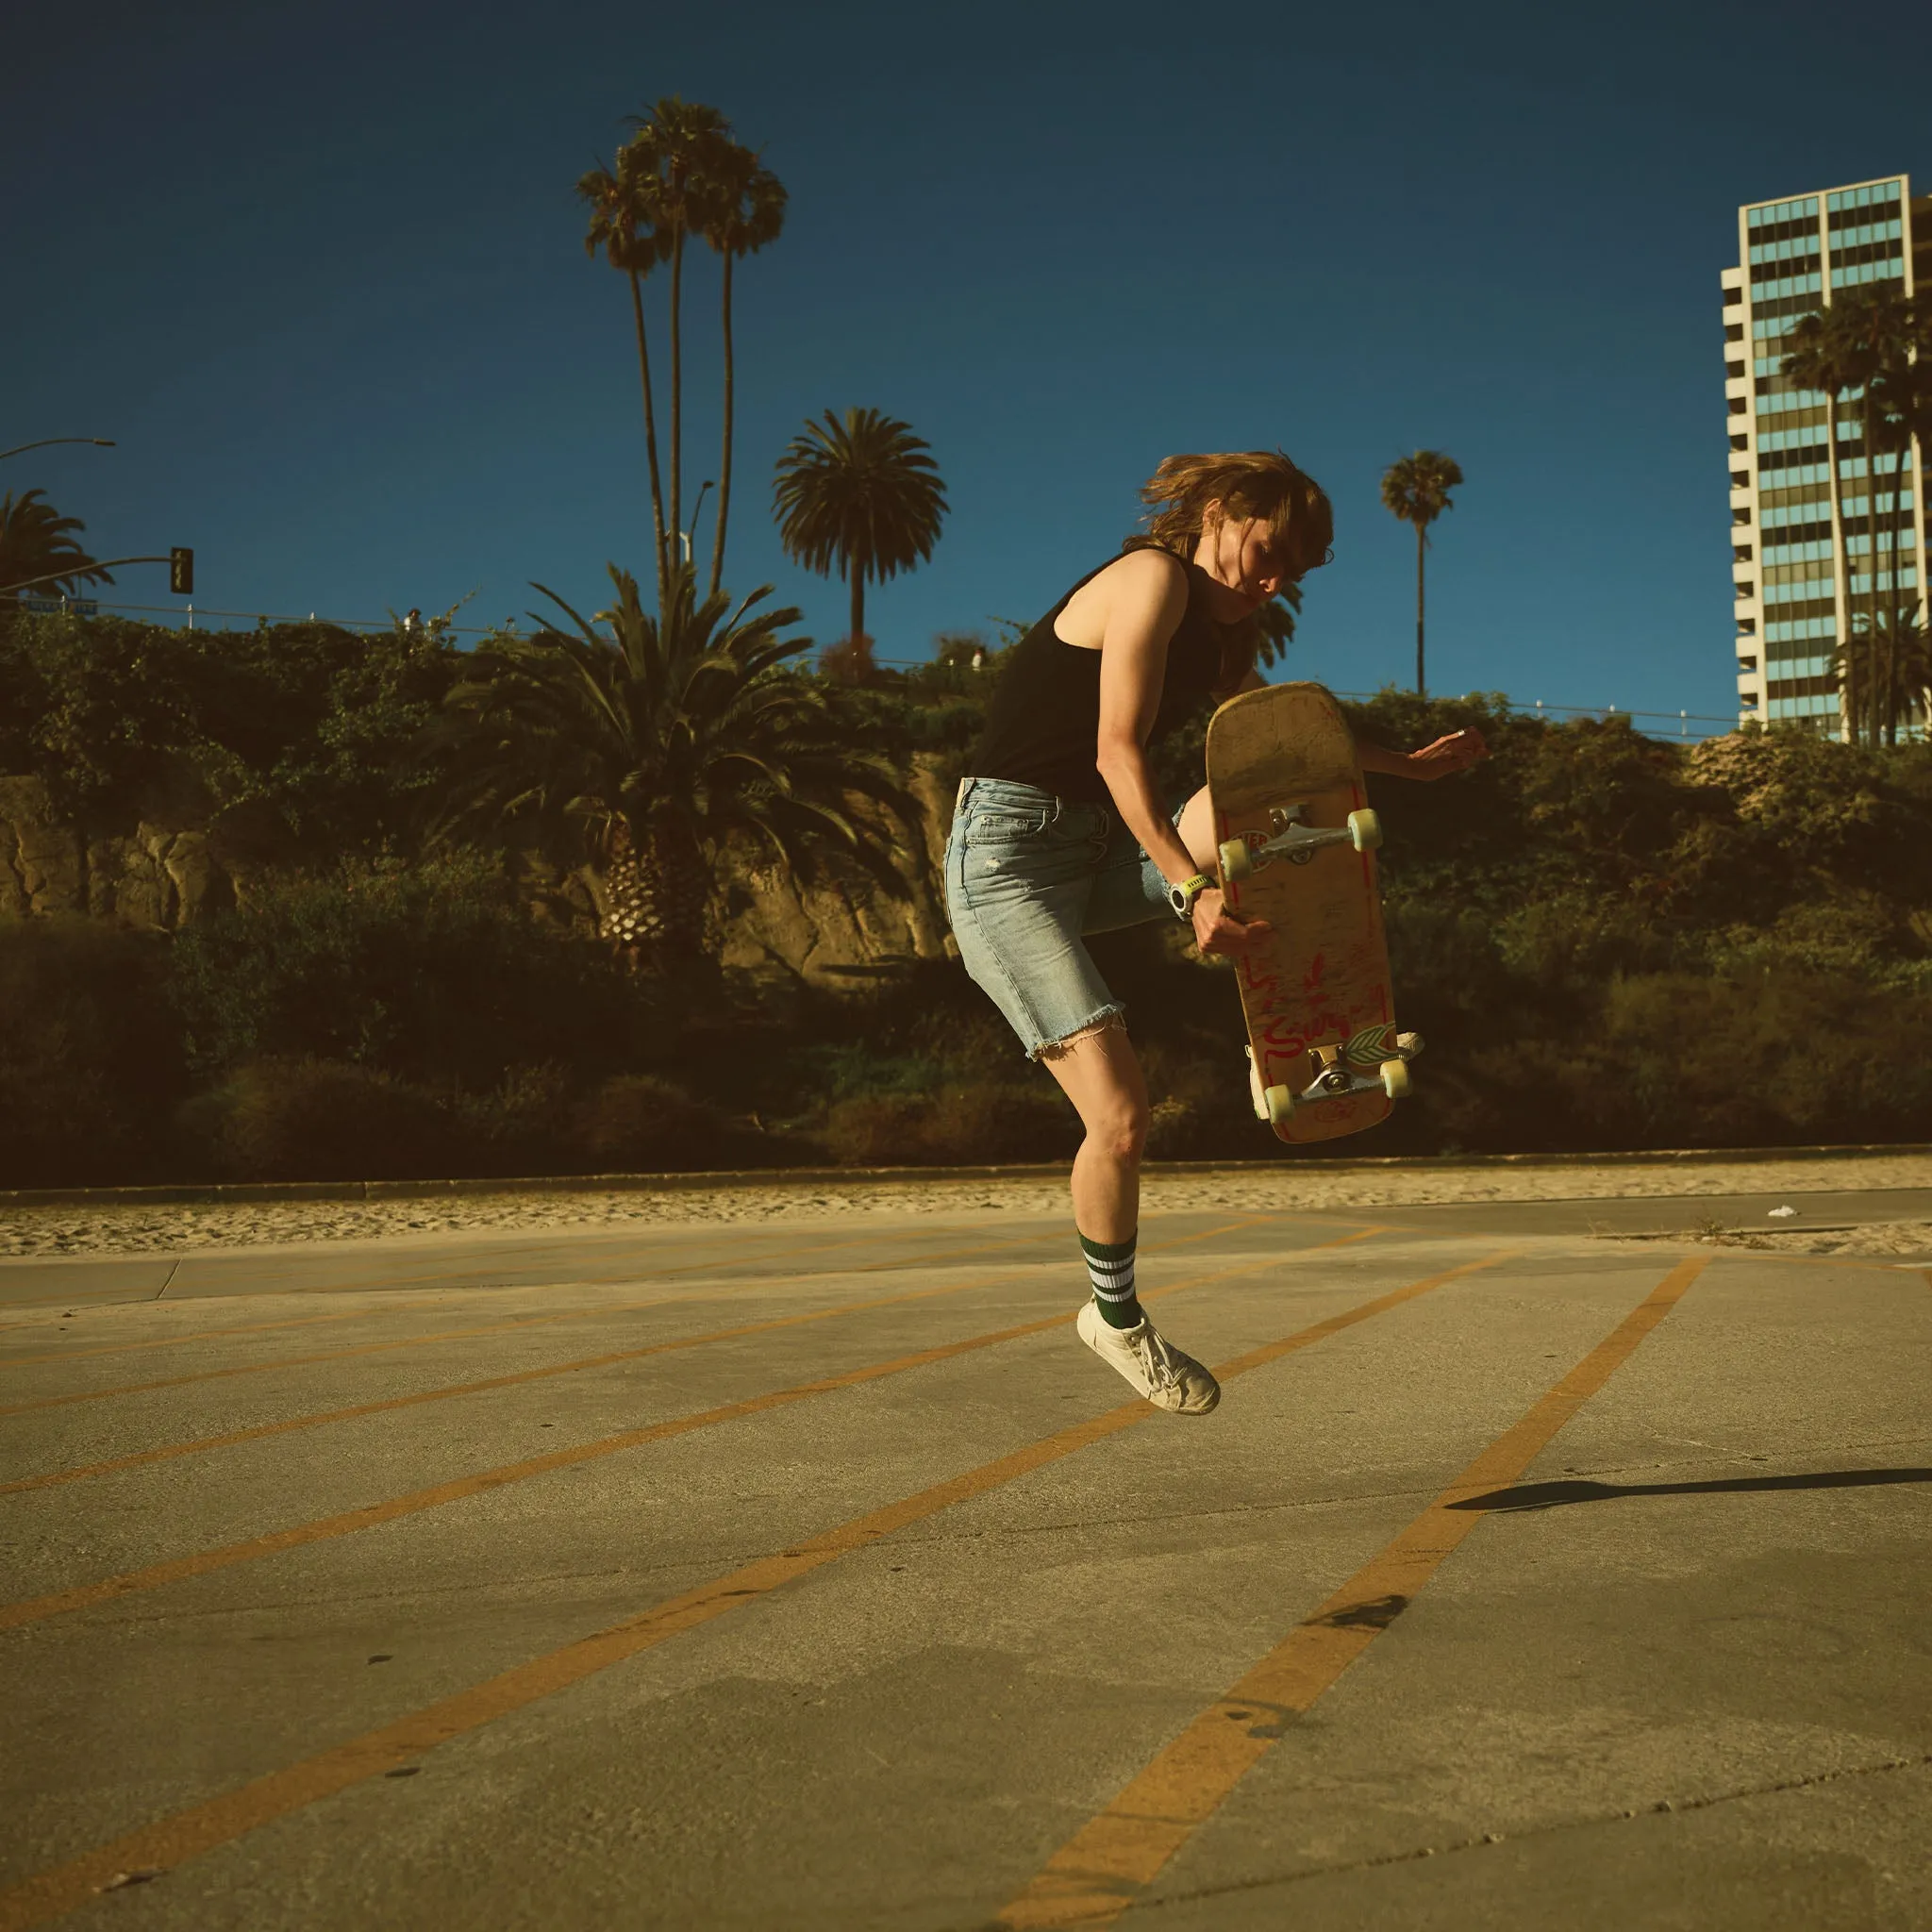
[0,1191,1932,1932]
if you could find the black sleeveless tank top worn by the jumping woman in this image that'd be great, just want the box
[966,553,1223,806]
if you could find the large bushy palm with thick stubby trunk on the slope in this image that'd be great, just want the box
[441,560,920,968]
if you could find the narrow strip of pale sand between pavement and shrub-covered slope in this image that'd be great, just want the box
[0,1154,1932,1257]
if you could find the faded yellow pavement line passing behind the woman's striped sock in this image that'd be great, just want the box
[0,1215,1344,1631]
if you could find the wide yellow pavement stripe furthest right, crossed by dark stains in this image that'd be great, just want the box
[995,1256,1707,1932]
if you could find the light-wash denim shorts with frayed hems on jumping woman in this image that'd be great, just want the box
[947,778,1178,1058]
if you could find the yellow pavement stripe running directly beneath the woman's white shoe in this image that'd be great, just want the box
[0,1233,1491,1932]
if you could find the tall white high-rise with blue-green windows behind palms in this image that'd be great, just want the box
[1720,175,1932,736]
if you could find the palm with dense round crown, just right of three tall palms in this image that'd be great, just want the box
[773,409,947,638]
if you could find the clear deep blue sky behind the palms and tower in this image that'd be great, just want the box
[0,0,1932,715]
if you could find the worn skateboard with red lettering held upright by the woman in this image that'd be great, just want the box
[1208,684,1422,1141]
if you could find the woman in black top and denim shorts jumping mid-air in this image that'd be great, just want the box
[947,450,1484,1416]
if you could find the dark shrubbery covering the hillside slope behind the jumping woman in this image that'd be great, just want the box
[0,612,1932,1186]
